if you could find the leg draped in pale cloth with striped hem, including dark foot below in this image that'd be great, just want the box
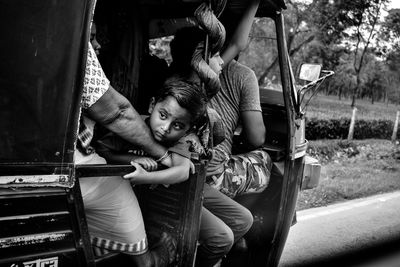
[81,177,175,267]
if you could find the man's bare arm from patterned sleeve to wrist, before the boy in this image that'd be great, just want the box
[87,85,167,161]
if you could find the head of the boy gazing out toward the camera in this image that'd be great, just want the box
[149,78,206,144]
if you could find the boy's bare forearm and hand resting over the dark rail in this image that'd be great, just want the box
[123,153,193,184]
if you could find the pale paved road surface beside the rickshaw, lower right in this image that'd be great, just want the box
[279,192,400,267]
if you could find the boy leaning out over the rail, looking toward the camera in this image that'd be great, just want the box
[97,78,206,184]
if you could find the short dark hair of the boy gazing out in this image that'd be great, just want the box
[155,77,207,126]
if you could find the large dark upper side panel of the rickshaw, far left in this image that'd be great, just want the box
[0,0,92,187]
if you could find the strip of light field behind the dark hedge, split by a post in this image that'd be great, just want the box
[306,94,400,121]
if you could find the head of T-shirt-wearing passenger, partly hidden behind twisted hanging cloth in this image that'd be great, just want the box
[170,27,224,75]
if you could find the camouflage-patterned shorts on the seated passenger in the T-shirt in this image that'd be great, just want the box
[209,149,272,198]
